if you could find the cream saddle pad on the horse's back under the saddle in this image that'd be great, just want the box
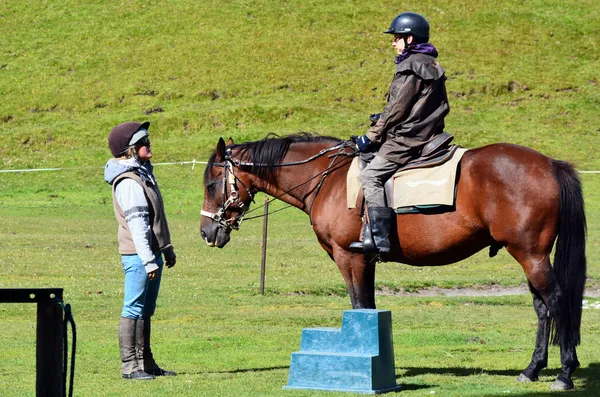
[346,148,468,208]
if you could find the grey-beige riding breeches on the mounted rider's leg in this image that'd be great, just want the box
[360,156,400,208]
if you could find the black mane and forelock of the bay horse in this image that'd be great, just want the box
[204,132,341,180]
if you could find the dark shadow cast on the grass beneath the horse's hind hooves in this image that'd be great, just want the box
[396,363,600,397]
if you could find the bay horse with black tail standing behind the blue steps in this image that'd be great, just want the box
[200,133,587,390]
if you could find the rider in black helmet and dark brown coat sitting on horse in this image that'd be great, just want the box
[350,12,450,254]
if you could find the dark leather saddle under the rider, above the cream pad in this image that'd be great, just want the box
[356,132,459,209]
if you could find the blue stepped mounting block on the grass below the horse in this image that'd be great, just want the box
[283,309,400,394]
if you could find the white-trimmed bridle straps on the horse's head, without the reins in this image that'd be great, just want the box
[200,149,255,233]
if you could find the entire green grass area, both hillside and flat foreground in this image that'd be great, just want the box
[0,0,600,397]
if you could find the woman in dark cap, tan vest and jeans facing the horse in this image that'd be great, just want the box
[104,122,176,380]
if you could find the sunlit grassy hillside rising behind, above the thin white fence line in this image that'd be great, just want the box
[0,0,600,168]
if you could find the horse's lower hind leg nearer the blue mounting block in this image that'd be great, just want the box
[517,283,550,382]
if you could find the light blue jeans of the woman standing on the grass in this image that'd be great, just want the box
[121,251,163,320]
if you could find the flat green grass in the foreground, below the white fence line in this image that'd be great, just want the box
[0,165,600,396]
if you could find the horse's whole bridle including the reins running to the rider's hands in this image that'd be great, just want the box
[200,141,357,233]
